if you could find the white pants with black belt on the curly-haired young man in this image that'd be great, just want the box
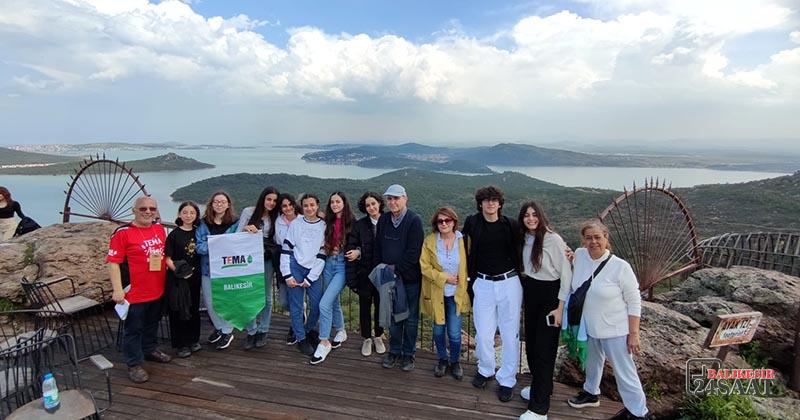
[472,276,522,388]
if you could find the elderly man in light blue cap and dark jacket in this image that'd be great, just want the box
[374,184,424,372]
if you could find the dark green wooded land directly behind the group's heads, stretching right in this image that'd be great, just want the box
[172,169,800,244]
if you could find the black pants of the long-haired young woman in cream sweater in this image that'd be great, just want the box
[522,277,561,415]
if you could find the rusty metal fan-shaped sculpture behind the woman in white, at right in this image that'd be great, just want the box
[598,179,700,298]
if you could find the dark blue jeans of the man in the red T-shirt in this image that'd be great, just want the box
[122,298,161,367]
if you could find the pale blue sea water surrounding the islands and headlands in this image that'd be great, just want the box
[0,145,786,226]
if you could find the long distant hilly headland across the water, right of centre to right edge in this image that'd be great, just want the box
[303,143,800,173]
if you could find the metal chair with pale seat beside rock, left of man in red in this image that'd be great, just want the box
[21,276,114,359]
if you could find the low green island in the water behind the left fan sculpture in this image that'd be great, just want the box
[0,149,214,175]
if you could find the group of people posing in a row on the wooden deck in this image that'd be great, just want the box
[107,184,648,419]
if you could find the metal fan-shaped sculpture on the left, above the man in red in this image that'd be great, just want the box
[63,154,149,223]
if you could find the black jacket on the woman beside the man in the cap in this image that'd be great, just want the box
[345,216,376,295]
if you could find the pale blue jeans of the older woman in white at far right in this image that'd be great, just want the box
[583,335,647,417]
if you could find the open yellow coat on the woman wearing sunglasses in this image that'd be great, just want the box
[419,232,470,325]
